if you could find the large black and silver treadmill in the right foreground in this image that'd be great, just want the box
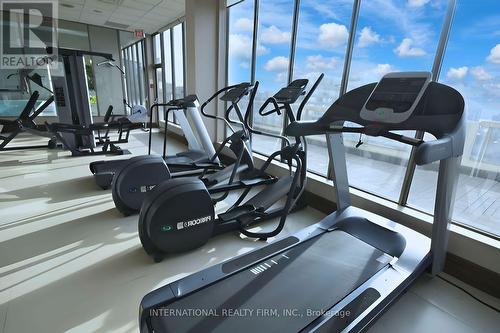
[139,72,465,333]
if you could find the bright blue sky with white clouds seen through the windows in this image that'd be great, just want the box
[229,0,500,120]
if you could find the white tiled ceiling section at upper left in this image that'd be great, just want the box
[58,0,185,33]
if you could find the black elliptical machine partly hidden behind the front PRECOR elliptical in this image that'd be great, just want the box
[112,83,257,215]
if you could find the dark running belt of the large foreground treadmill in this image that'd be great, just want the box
[151,230,392,333]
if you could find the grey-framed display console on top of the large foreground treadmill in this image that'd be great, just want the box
[360,72,431,124]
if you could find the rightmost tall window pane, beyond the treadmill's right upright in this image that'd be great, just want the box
[408,0,500,236]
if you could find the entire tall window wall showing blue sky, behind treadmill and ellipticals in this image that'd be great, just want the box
[227,0,500,235]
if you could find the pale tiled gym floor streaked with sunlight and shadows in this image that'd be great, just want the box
[0,133,500,333]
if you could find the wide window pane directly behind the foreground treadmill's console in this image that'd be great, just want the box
[344,0,447,201]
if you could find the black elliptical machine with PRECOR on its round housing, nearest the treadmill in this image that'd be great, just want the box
[138,75,323,262]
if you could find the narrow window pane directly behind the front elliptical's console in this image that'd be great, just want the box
[252,0,294,155]
